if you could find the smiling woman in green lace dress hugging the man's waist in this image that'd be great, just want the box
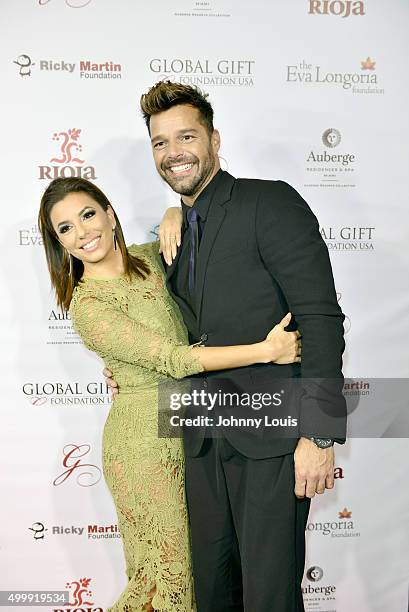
[39,178,300,612]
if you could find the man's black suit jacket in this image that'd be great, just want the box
[167,172,346,458]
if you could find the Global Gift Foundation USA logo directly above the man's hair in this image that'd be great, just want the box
[149,58,256,87]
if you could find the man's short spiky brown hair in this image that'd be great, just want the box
[141,81,214,136]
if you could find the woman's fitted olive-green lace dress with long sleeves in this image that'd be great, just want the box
[70,242,203,612]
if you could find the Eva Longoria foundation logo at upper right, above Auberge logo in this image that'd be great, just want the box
[286,57,385,94]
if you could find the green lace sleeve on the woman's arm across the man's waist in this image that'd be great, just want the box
[71,296,203,378]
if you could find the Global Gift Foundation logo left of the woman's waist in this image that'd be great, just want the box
[22,381,111,406]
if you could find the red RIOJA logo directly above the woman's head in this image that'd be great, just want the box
[38,128,97,180]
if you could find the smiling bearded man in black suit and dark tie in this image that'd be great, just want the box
[108,82,345,612]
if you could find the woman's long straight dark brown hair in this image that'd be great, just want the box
[38,178,149,310]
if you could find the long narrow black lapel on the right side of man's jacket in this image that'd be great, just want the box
[196,172,235,327]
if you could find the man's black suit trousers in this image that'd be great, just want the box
[186,438,310,612]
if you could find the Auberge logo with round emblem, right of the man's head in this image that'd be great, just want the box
[304,128,357,188]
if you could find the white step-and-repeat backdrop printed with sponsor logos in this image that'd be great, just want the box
[0,0,409,612]
